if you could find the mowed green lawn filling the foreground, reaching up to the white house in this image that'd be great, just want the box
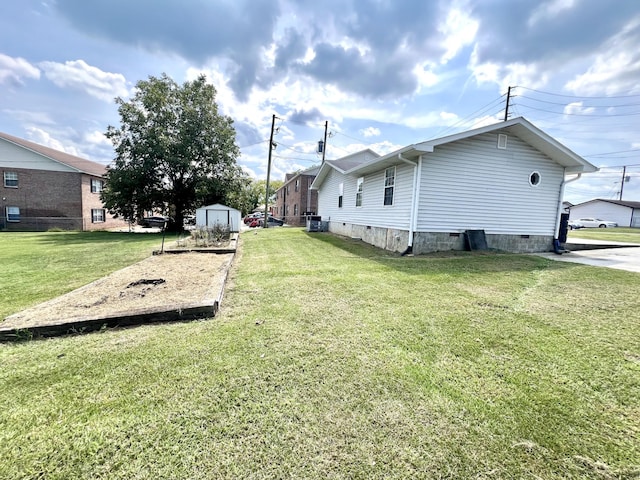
[0,228,640,479]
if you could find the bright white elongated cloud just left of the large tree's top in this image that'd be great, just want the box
[39,60,129,102]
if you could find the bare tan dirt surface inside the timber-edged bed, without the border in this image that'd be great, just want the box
[0,252,234,329]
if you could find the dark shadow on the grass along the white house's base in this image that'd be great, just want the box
[306,232,580,275]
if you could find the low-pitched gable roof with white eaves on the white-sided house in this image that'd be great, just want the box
[312,117,598,188]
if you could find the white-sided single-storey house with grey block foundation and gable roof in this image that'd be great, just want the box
[311,117,597,254]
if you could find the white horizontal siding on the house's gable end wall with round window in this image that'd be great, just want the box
[417,133,564,235]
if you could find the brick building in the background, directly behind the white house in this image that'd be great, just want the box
[275,167,320,226]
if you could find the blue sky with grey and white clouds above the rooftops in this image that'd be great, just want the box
[0,0,640,203]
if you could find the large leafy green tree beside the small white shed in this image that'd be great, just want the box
[102,74,246,229]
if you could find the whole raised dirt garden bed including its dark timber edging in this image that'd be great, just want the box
[0,251,234,340]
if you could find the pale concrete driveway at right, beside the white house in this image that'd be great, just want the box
[536,240,640,273]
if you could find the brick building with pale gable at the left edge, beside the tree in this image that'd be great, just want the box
[0,133,127,231]
